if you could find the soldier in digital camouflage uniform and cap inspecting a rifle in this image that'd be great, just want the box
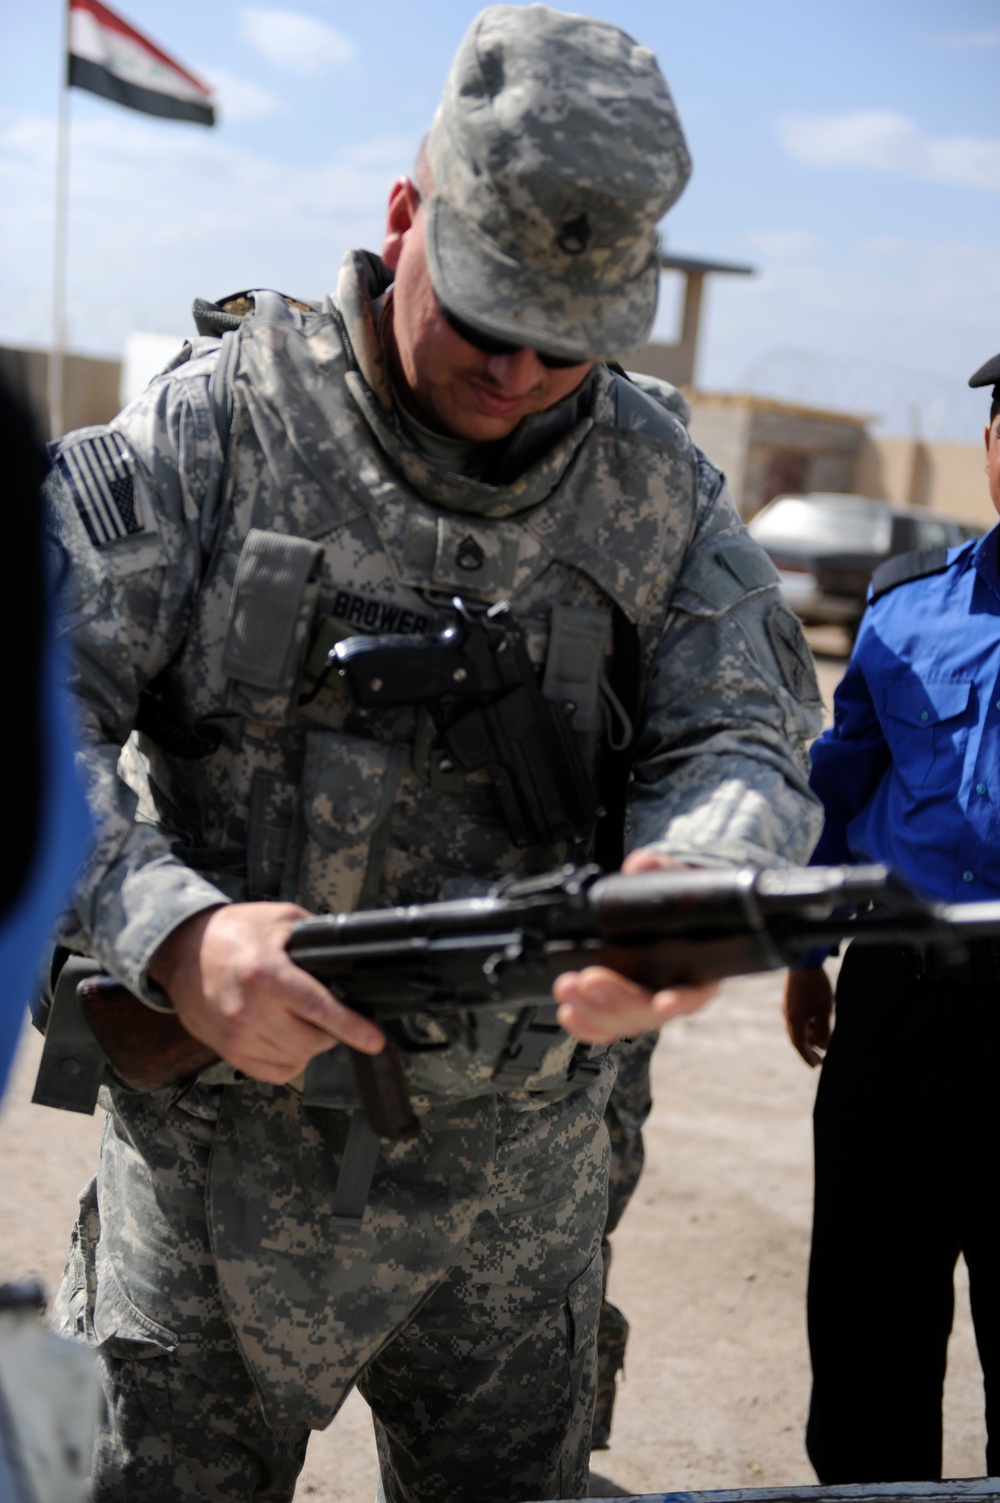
[42,6,818,1503]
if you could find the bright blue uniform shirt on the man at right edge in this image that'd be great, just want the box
[811,528,1000,902]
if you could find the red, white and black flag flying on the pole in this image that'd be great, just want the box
[69,0,215,125]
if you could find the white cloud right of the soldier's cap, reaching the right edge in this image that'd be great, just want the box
[777,110,1000,192]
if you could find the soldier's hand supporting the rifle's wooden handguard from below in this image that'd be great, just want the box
[552,851,719,1043]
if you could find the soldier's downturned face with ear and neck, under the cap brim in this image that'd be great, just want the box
[382,177,591,443]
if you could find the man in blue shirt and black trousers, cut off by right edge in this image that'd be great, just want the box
[785,355,1000,1485]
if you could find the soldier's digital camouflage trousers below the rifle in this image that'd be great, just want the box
[54,1063,614,1503]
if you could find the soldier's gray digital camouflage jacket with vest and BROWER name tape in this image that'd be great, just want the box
[50,254,820,1070]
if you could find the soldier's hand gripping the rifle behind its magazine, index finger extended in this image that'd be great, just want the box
[149,903,385,1085]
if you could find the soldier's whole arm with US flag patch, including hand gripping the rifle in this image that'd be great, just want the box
[47,359,382,1081]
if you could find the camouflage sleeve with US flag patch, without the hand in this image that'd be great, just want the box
[47,345,226,1006]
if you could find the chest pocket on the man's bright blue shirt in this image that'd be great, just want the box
[886,678,973,792]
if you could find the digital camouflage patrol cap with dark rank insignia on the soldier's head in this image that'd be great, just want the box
[426,5,690,361]
